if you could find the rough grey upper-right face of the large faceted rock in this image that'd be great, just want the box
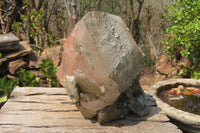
[82,12,144,92]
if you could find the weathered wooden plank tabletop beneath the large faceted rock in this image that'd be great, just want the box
[0,87,181,133]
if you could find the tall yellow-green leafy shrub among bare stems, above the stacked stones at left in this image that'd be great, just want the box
[11,0,59,53]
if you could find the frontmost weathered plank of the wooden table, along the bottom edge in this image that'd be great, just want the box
[0,121,181,133]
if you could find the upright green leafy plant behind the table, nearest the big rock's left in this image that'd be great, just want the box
[40,58,58,87]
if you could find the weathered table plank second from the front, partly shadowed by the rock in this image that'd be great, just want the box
[0,108,168,127]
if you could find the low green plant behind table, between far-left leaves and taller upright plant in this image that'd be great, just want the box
[17,68,40,87]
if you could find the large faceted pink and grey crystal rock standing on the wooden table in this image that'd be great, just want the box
[57,12,149,123]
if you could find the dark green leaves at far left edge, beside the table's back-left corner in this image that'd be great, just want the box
[0,76,18,95]
